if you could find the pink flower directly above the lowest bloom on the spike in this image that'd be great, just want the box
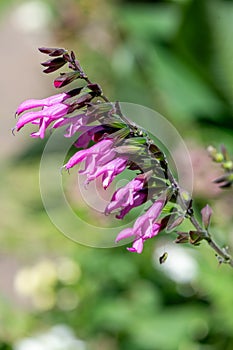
[105,176,147,219]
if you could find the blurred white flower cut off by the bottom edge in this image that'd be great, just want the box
[13,325,86,350]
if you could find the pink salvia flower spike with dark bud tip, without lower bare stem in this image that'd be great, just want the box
[14,48,177,253]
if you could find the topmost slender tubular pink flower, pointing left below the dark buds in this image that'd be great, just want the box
[16,92,70,115]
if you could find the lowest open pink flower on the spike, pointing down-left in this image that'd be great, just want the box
[116,197,166,254]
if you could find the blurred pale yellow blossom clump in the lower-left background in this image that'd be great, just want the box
[14,257,81,311]
